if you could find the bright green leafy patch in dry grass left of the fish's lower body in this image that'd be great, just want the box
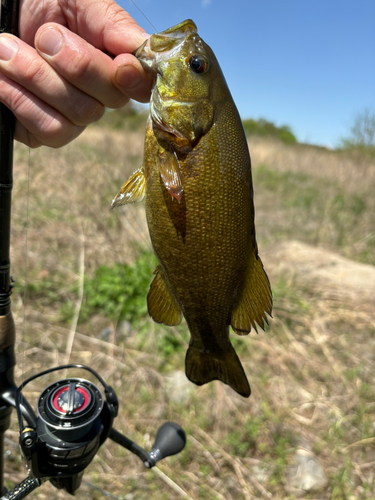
[25,250,189,357]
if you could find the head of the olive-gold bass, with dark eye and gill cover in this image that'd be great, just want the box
[134,19,225,148]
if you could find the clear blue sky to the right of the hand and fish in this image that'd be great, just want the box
[118,0,375,147]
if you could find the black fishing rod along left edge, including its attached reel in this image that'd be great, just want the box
[0,0,186,500]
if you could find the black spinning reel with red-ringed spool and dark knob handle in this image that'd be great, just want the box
[1,365,186,500]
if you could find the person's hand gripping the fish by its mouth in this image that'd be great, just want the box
[0,0,151,148]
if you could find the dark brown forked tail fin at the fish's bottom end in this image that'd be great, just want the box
[185,344,251,398]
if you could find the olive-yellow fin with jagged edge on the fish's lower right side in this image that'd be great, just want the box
[231,253,272,335]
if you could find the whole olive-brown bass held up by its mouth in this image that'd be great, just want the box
[112,19,272,397]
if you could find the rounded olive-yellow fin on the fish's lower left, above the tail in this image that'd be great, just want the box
[147,266,182,326]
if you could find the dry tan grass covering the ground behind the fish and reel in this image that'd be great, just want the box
[6,129,375,500]
